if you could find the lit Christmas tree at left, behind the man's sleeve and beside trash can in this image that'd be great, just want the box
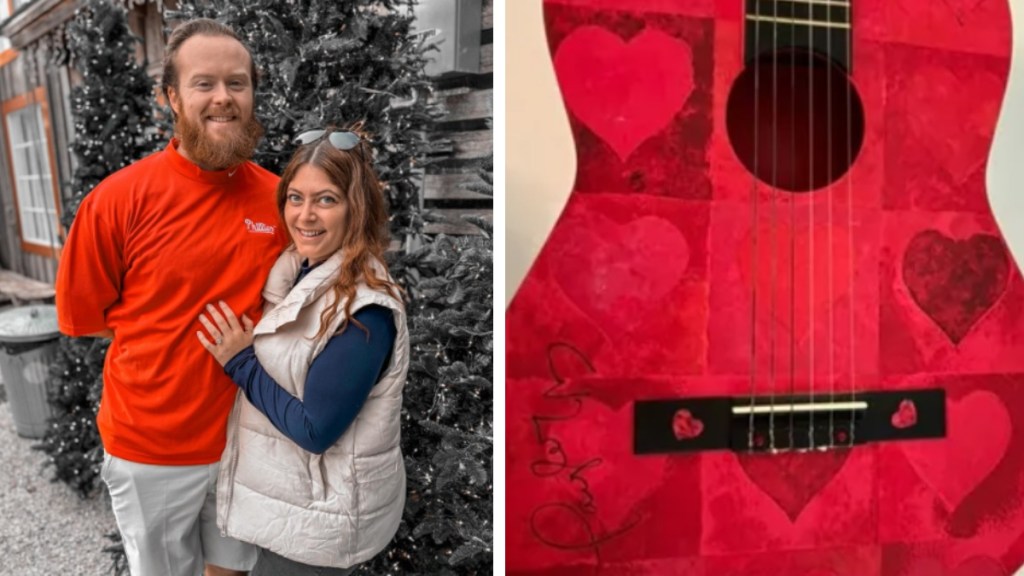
[38,0,162,497]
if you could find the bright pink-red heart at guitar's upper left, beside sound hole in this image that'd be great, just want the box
[554,26,693,161]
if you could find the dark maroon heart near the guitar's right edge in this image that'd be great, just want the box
[903,230,1010,344]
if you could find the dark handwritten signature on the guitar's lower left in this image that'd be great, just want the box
[529,342,641,561]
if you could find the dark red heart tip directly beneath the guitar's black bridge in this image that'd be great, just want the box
[736,450,849,522]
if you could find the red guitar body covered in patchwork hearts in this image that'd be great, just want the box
[506,0,1024,576]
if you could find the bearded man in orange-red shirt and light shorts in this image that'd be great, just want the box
[56,19,287,576]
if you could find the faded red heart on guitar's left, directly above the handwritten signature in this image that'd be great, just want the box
[548,213,690,332]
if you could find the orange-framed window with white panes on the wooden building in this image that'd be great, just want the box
[3,88,60,251]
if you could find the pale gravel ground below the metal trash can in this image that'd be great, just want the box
[0,402,115,576]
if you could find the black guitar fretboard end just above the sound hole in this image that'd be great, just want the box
[743,0,852,73]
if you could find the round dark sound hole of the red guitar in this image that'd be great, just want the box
[726,52,864,192]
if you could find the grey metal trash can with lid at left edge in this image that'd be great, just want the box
[0,304,60,438]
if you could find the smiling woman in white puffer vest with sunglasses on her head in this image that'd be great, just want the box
[198,126,409,576]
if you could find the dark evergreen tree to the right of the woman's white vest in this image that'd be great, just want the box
[365,154,494,575]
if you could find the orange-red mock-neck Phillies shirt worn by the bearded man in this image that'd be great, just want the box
[56,140,288,465]
